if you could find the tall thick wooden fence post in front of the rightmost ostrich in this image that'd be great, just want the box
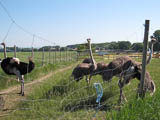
[139,20,150,98]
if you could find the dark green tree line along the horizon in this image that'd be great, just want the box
[0,30,160,52]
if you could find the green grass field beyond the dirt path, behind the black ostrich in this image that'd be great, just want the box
[0,51,76,90]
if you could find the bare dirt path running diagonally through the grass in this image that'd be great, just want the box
[0,65,73,116]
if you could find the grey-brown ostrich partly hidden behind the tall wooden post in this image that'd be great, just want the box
[101,39,156,103]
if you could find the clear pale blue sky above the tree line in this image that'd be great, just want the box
[0,0,160,47]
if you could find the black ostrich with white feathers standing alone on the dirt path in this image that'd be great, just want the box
[1,43,35,96]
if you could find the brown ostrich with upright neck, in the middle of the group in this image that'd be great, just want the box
[71,39,97,83]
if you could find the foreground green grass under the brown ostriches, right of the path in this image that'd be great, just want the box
[1,55,160,120]
